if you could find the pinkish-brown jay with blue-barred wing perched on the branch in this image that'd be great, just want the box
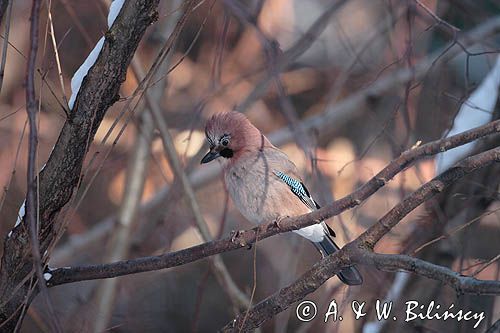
[201,111,363,285]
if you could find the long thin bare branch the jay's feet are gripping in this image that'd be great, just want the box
[45,121,500,286]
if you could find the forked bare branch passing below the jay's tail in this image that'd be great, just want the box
[222,148,500,332]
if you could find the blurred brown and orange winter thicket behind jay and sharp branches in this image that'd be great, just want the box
[0,0,500,333]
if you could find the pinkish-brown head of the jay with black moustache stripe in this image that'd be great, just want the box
[201,111,268,164]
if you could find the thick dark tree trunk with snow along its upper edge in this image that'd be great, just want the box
[0,0,159,329]
